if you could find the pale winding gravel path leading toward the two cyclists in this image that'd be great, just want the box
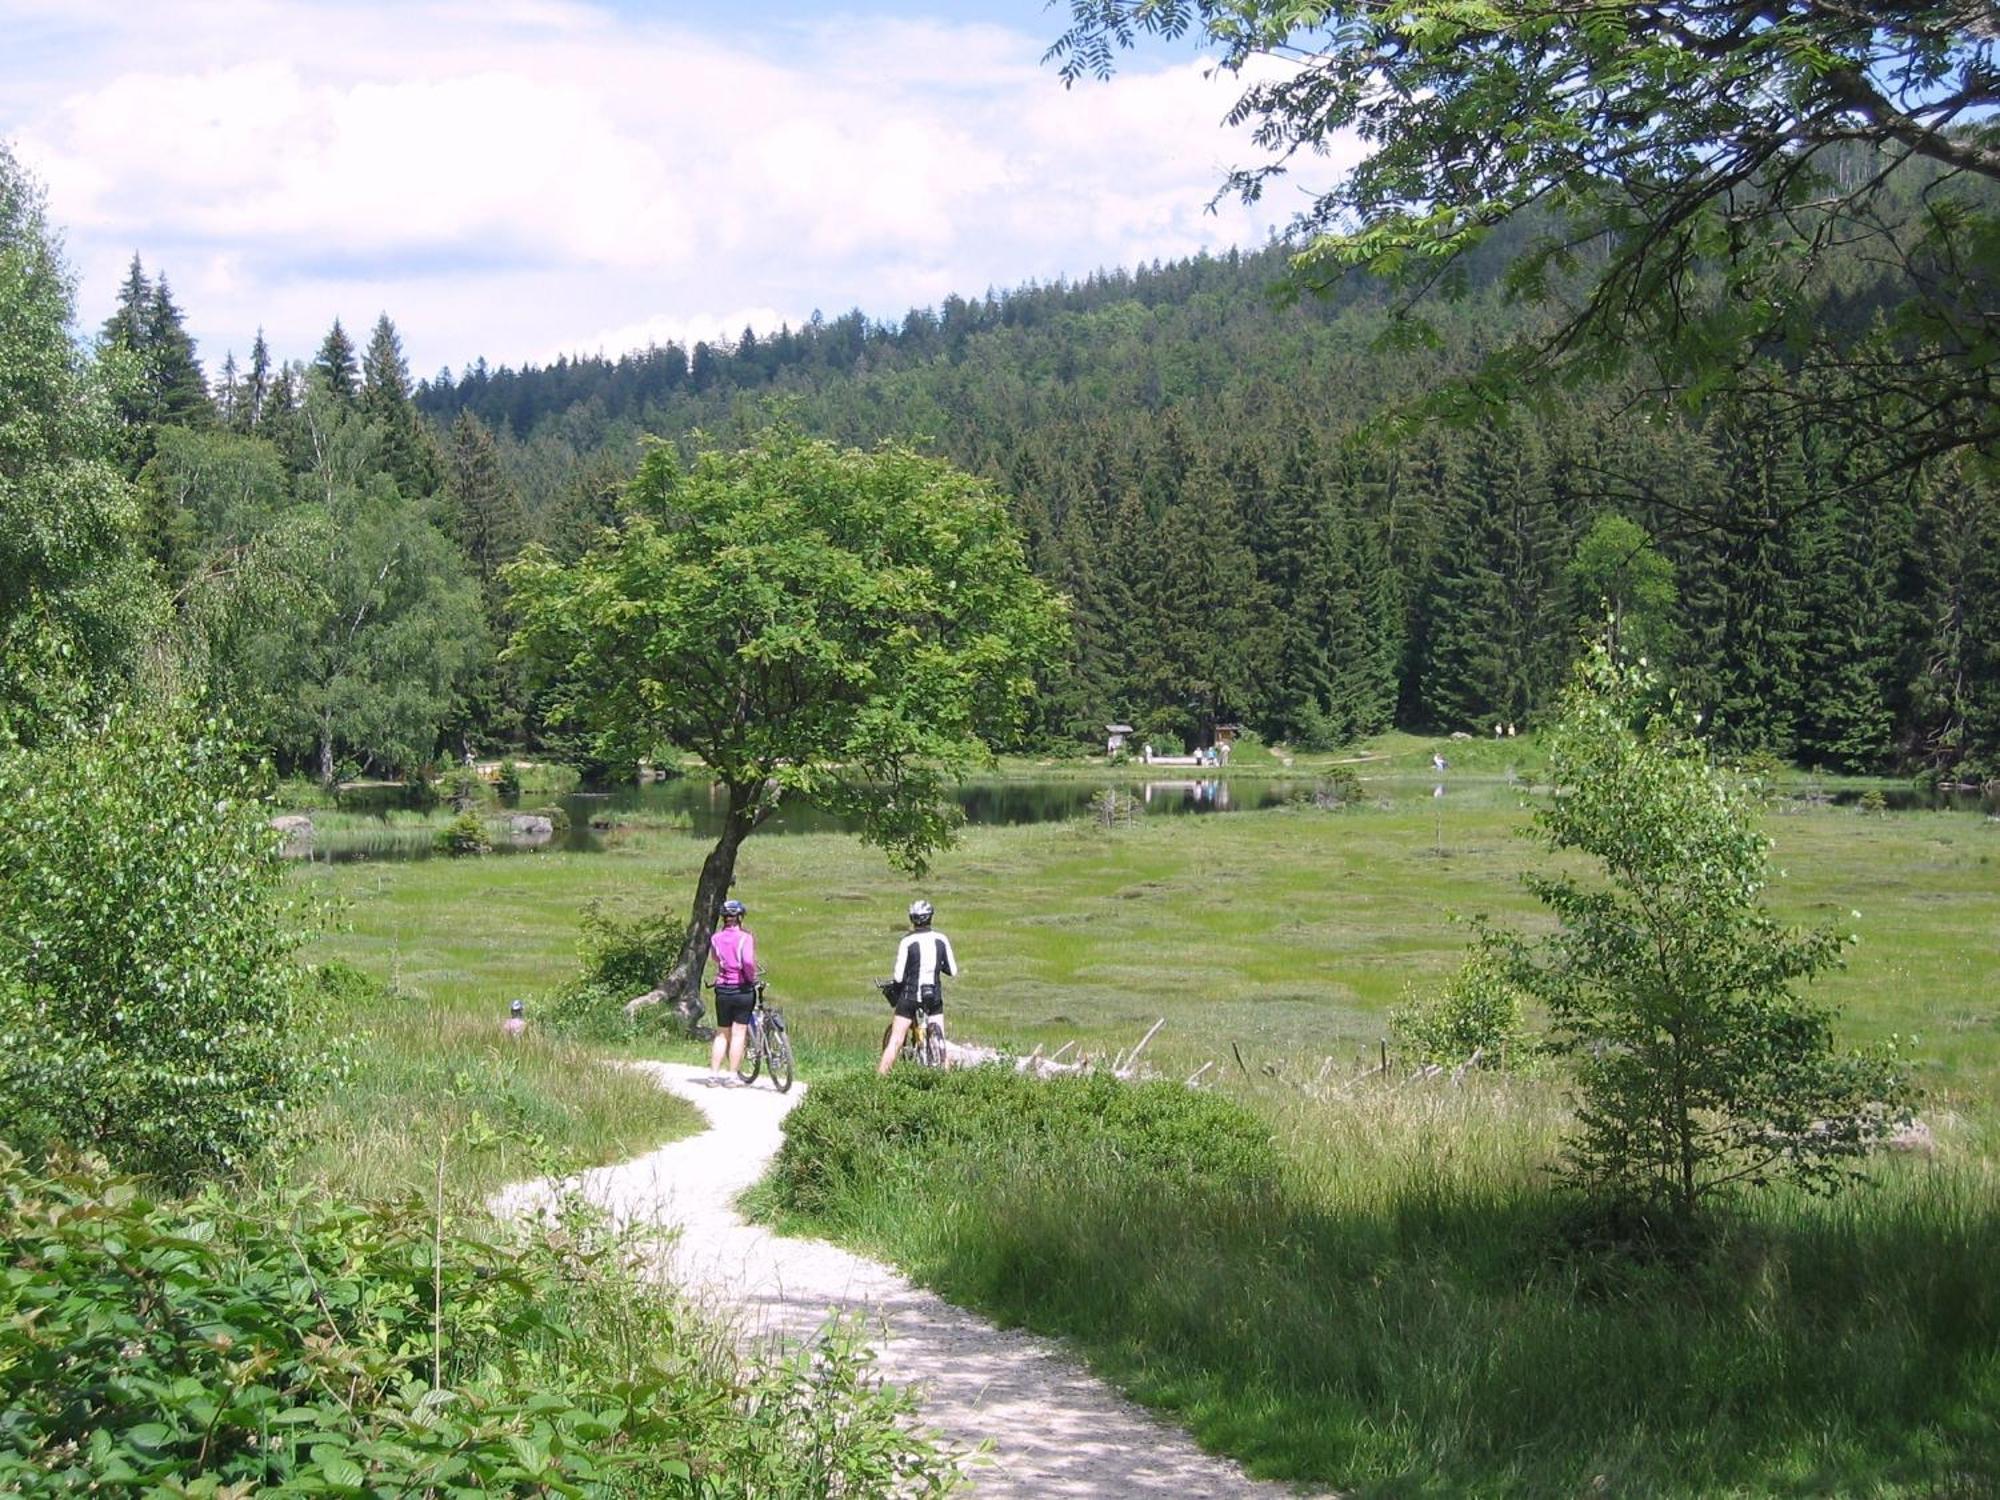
[492,1062,1296,1496]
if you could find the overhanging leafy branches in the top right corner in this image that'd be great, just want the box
[1050,0,2000,482]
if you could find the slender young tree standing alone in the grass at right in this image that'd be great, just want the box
[1500,646,1906,1220]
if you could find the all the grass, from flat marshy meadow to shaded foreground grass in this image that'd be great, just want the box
[300,768,2000,1496]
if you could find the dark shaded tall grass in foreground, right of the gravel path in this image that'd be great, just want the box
[796,1154,2000,1496]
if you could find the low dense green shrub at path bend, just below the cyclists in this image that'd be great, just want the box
[772,1068,1274,1214]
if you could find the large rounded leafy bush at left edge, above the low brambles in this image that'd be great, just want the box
[0,714,322,1180]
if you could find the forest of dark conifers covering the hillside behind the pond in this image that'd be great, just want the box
[117,184,2000,776]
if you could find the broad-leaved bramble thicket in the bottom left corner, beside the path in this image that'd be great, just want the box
[0,1154,950,1500]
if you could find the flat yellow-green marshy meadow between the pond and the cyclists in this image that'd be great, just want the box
[296,788,2000,1156]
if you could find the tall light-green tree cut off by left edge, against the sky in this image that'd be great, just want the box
[0,146,158,748]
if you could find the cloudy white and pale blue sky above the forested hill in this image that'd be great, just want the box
[0,0,1332,374]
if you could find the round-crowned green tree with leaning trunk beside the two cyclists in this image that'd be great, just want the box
[506,428,1064,1004]
